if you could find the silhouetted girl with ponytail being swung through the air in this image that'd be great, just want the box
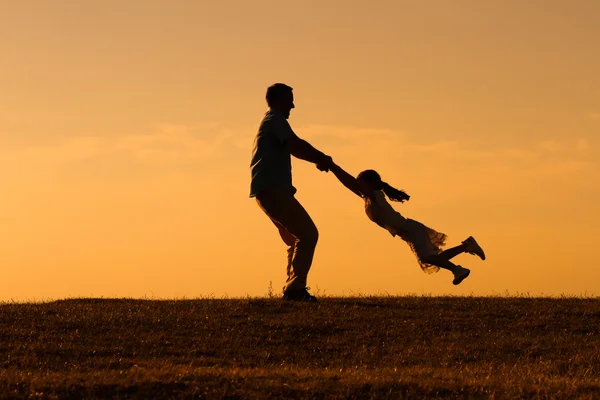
[331,164,485,285]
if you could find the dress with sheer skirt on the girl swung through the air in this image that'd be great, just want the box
[365,190,446,274]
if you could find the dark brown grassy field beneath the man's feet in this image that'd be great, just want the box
[0,297,600,399]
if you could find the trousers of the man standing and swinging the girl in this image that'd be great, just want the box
[256,190,319,292]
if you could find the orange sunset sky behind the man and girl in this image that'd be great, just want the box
[0,0,600,301]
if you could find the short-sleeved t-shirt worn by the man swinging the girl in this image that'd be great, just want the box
[250,109,296,197]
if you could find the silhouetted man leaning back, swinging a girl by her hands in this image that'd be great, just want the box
[250,83,333,301]
